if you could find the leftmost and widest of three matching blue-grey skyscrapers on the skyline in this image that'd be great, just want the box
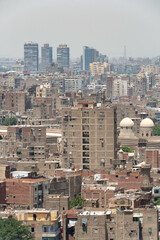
[24,42,39,72]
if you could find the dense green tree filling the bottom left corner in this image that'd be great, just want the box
[0,218,33,240]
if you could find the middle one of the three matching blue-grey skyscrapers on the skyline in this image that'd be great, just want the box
[41,43,52,71]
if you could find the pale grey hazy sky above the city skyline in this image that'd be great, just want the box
[0,0,160,59]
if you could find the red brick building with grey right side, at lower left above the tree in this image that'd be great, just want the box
[6,179,49,209]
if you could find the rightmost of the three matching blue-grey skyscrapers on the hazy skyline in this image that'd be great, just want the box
[57,44,70,69]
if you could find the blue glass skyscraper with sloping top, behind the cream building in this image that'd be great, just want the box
[83,46,98,71]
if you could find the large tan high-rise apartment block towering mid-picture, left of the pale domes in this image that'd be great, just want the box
[63,100,116,170]
